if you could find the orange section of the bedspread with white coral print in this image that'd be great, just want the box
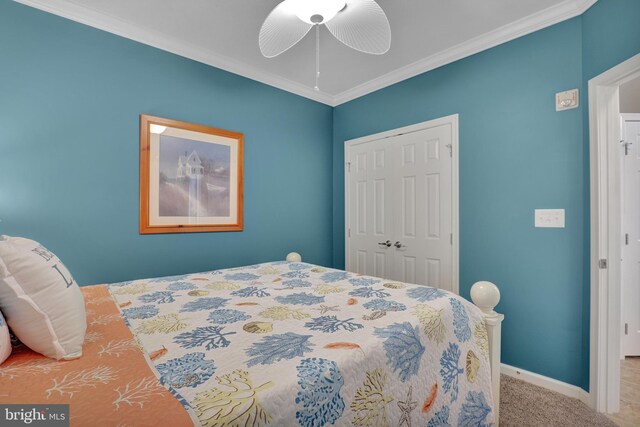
[0,286,197,427]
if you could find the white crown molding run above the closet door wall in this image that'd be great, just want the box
[333,0,597,106]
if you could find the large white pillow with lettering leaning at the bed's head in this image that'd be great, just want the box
[0,236,87,360]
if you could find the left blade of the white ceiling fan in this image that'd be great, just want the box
[259,1,313,58]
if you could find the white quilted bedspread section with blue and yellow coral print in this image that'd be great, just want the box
[106,262,494,426]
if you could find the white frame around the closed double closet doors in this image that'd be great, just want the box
[344,114,460,294]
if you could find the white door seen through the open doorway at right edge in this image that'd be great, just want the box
[621,115,640,356]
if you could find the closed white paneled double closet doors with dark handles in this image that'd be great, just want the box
[346,118,457,291]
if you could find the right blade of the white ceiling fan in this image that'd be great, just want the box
[325,0,391,55]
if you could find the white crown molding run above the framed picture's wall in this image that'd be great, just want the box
[14,0,334,106]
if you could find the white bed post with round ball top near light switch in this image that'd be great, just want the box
[471,282,504,425]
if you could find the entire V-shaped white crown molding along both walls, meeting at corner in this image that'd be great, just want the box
[14,0,597,107]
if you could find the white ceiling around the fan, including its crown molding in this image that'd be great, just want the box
[17,0,596,105]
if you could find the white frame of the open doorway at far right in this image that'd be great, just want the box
[589,54,640,413]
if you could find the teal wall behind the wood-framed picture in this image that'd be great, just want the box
[0,0,332,284]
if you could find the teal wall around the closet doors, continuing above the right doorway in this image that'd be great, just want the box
[333,0,640,389]
